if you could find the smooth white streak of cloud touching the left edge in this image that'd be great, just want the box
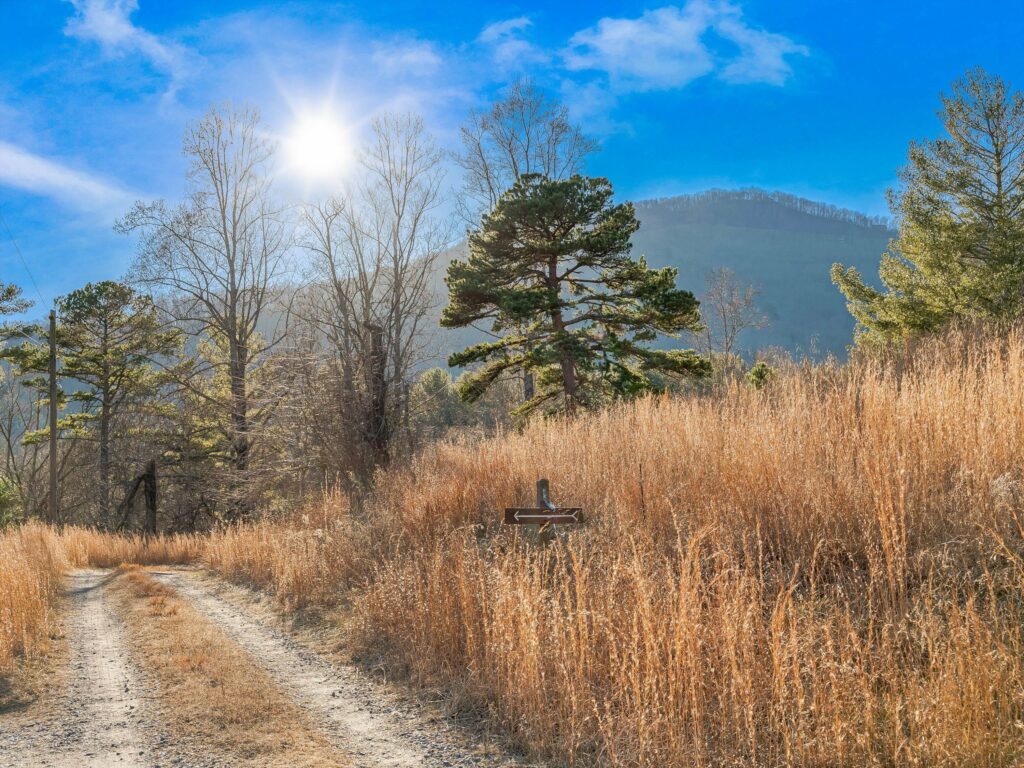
[0,140,132,211]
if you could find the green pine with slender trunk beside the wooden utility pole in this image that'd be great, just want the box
[4,281,181,523]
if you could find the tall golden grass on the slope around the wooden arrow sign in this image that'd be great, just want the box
[206,325,1024,766]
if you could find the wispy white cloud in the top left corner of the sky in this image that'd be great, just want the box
[65,0,187,93]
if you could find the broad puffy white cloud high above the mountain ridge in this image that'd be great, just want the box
[564,0,808,91]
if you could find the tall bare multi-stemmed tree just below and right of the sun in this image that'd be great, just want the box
[305,115,451,473]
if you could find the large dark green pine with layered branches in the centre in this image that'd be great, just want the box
[441,175,709,415]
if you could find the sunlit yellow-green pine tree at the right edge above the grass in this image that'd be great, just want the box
[831,69,1024,342]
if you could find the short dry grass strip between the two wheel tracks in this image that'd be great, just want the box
[115,566,348,768]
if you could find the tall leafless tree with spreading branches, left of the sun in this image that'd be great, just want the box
[118,100,290,512]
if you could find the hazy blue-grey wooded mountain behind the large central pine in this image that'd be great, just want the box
[425,189,894,358]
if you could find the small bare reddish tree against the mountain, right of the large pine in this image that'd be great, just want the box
[697,267,768,371]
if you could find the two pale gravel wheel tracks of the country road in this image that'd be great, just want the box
[0,569,525,768]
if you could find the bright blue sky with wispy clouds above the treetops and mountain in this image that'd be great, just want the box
[0,0,1024,311]
